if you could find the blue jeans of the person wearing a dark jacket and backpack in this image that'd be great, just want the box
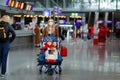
[0,42,10,74]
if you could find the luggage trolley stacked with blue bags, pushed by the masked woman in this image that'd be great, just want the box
[38,36,63,75]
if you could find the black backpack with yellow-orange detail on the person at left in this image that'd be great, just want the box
[0,23,7,42]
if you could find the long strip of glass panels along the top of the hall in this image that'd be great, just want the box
[32,0,120,11]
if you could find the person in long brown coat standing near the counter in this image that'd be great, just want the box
[34,24,40,47]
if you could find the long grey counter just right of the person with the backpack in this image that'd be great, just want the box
[11,30,34,49]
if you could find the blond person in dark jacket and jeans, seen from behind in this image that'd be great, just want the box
[0,15,16,78]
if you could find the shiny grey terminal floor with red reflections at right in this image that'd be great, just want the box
[0,39,120,80]
